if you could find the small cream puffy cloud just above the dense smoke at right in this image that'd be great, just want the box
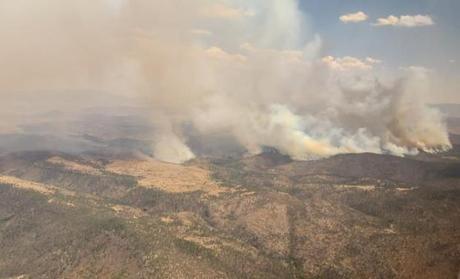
[322,56,382,71]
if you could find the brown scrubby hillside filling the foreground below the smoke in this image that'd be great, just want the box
[0,149,460,278]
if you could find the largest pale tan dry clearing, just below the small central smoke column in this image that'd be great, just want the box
[106,160,229,196]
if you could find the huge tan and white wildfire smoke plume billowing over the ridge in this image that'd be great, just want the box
[0,0,451,162]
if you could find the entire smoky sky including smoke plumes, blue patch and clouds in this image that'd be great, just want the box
[0,0,454,162]
